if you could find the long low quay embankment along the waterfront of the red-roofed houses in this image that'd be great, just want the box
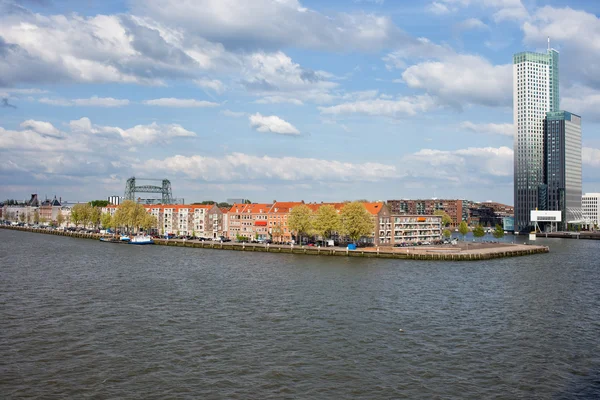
[0,226,550,261]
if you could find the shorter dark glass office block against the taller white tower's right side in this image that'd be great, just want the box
[538,111,582,230]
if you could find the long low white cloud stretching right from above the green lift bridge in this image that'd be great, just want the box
[135,153,398,182]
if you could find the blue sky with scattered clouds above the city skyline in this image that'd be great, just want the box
[0,0,600,204]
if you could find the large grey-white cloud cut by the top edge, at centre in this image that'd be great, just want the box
[133,0,403,51]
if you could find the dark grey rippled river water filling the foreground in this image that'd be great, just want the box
[0,230,600,399]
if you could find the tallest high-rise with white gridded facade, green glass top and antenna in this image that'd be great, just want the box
[513,42,559,231]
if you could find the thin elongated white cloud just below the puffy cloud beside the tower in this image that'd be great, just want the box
[319,95,436,118]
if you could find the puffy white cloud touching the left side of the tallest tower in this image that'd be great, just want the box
[402,55,512,108]
